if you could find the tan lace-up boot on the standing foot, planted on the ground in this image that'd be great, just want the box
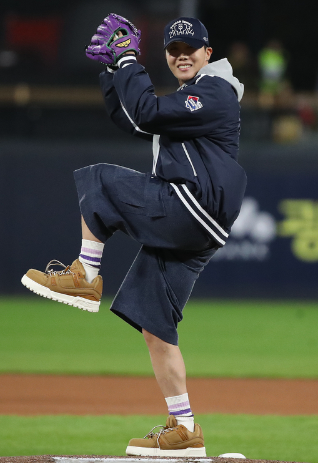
[126,415,206,457]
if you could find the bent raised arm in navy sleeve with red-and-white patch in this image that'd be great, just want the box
[114,62,239,138]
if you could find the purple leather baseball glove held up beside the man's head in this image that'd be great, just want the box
[86,13,141,66]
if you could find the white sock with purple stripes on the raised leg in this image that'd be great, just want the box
[79,239,104,283]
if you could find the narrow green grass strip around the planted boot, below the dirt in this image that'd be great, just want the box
[0,415,318,463]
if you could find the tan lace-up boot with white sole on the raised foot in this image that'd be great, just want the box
[21,259,103,312]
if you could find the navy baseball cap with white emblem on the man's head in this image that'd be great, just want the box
[164,16,209,48]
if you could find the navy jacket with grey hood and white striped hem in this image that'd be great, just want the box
[100,59,246,246]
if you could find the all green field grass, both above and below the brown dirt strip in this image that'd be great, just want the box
[0,296,318,463]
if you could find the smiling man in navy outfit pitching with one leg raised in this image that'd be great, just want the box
[22,14,246,457]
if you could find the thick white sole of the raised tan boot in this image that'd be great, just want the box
[21,275,100,312]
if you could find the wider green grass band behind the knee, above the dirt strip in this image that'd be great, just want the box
[0,296,318,378]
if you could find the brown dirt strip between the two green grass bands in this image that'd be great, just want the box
[0,375,318,415]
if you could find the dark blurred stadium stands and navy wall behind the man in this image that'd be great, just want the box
[0,0,318,299]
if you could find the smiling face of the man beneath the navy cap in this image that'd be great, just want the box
[166,42,212,85]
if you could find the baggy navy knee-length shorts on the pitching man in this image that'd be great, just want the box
[74,164,218,345]
